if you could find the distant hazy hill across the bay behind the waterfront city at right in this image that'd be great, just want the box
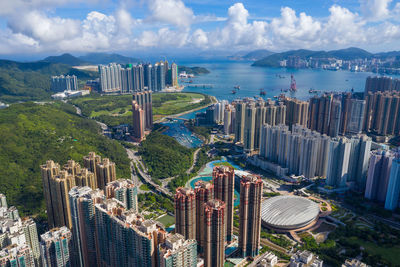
[252,47,373,67]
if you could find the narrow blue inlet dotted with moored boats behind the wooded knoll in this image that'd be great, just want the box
[162,119,203,148]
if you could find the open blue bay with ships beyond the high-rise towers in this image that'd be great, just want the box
[178,61,400,101]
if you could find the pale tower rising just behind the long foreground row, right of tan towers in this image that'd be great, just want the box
[104,179,139,212]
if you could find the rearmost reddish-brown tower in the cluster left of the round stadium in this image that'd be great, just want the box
[212,166,235,242]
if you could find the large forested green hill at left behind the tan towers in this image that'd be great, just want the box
[0,102,130,217]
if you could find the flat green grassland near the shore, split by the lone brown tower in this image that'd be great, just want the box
[71,93,211,126]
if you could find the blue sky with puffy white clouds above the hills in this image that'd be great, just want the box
[0,0,400,55]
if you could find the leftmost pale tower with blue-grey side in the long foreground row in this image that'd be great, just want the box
[69,186,105,266]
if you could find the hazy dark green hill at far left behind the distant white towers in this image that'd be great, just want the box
[0,60,98,102]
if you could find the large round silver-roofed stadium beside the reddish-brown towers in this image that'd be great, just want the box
[261,196,320,231]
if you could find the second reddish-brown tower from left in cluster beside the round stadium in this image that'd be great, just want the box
[194,181,214,253]
